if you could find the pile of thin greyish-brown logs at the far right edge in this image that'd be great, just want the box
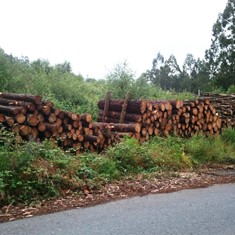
[203,93,235,128]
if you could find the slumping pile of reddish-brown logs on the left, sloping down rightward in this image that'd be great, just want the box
[0,93,118,153]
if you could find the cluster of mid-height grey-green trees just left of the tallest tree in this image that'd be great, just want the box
[142,53,211,93]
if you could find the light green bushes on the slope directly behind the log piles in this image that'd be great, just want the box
[0,49,196,120]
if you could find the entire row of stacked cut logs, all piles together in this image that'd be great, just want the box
[0,93,228,153]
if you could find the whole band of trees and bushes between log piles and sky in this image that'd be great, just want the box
[0,0,235,112]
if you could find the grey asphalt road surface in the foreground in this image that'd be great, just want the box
[0,184,235,235]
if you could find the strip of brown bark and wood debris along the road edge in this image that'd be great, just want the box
[0,165,235,222]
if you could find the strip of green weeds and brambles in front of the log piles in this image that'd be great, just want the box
[0,124,235,206]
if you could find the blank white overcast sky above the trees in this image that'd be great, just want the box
[0,0,227,78]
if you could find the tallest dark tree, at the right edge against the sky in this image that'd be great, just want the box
[206,0,235,90]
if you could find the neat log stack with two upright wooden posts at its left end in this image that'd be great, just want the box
[98,99,221,142]
